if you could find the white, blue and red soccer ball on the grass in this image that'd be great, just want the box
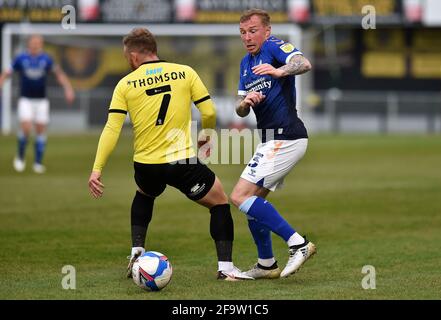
[132,251,173,291]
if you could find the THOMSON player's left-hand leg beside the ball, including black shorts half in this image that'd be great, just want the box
[127,162,166,278]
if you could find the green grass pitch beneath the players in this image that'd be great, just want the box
[0,134,441,300]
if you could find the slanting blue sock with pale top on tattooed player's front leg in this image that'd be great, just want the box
[239,196,296,241]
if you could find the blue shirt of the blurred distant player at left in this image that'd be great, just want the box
[12,53,54,98]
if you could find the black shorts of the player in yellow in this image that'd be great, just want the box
[134,158,216,201]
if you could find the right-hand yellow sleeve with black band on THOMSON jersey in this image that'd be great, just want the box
[191,69,216,129]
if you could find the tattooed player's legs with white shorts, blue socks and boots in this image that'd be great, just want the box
[231,139,315,276]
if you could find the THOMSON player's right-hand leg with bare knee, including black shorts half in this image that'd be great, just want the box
[168,161,252,281]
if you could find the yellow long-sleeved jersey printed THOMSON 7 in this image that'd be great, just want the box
[93,60,216,171]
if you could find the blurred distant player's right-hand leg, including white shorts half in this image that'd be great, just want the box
[33,99,49,173]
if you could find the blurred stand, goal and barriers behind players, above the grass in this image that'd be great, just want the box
[0,0,441,134]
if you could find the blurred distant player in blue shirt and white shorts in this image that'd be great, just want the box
[0,35,75,173]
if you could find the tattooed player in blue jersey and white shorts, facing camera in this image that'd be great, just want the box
[231,9,316,279]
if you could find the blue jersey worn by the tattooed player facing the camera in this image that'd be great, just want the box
[238,36,308,142]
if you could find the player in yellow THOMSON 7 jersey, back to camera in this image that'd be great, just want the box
[89,28,253,281]
